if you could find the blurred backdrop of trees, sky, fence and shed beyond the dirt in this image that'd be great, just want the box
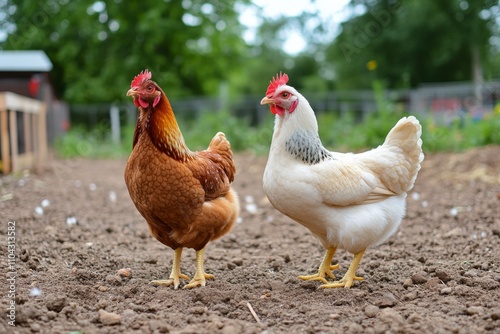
[0,0,500,167]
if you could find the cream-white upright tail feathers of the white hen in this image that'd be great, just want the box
[384,116,424,191]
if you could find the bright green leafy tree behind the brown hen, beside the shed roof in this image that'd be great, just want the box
[0,0,249,103]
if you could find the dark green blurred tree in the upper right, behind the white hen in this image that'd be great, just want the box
[327,0,500,88]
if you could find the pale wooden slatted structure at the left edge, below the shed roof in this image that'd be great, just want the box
[0,92,47,174]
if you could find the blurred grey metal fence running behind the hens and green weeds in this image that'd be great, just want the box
[70,81,500,132]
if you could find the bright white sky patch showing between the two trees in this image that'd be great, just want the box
[240,0,352,55]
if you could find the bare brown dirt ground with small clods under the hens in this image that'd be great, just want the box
[0,146,500,334]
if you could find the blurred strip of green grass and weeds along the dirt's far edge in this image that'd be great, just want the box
[55,110,500,158]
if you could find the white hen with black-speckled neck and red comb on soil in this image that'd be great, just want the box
[261,73,424,288]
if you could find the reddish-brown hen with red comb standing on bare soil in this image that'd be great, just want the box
[125,70,239,289]
